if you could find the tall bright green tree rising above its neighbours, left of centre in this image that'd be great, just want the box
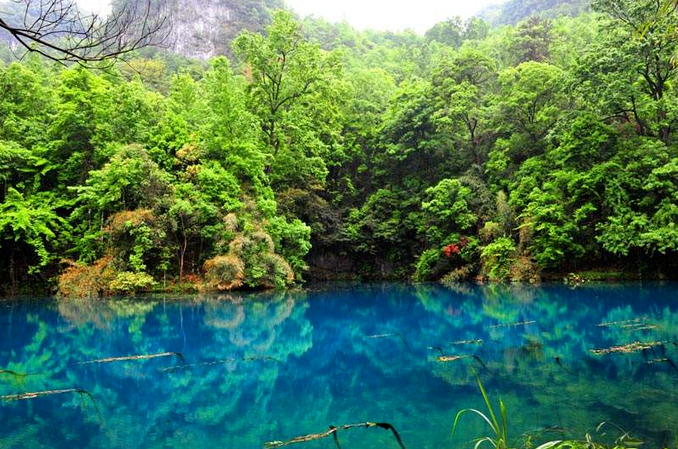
[234,11,341,190]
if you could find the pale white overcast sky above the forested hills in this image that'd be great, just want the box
[78,0,500,32]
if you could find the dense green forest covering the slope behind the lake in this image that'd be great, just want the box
[0,0,678,297]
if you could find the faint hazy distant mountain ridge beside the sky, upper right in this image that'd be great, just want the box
[477,0,591,26]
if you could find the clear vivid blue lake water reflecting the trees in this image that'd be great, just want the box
[0,284,678,449]
